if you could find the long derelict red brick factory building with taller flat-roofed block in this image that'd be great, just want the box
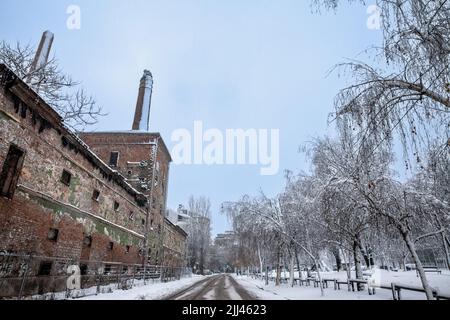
[0,65,186,294]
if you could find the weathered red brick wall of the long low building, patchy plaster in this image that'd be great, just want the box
[0,83,150,263]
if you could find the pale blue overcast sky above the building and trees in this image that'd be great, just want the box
[0,0,381,234]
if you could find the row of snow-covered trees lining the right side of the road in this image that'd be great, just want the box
[223,0,450,299]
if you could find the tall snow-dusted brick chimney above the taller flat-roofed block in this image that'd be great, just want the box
[132,70,153,131]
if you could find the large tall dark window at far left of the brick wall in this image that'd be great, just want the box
[0,145,25,199]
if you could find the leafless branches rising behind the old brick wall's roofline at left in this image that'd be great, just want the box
[0,41,105,130]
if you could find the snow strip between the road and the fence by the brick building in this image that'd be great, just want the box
[79,275,205,300]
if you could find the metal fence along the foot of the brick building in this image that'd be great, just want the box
[0,252,191,300]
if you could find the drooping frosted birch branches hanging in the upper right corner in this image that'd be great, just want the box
[313,0,450,162]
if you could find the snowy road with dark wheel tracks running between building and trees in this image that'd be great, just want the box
[165,274,256,300]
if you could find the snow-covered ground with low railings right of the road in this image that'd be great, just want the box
[234,270,450,300]
